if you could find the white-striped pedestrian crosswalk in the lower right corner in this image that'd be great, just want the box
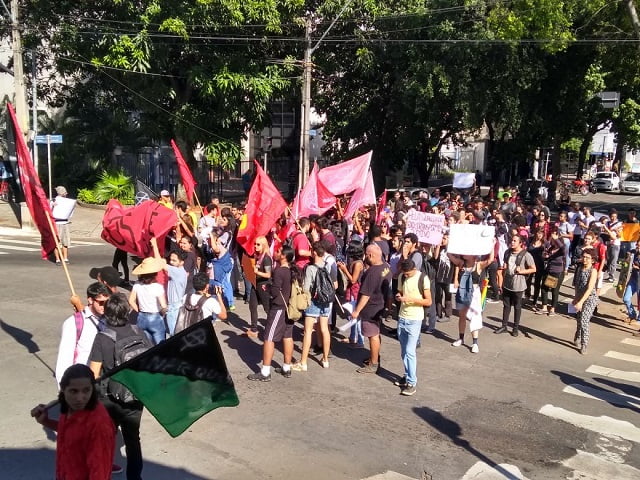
[539,338,640,479]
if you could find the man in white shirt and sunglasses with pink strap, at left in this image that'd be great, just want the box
[56,282,111,385]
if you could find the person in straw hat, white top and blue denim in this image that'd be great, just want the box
[129,257,167,344]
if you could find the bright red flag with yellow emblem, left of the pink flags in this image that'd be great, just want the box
[236,162,287,255]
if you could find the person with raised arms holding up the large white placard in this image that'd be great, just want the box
[447,248,494,353]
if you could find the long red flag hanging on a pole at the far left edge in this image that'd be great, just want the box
[7,103,58,255]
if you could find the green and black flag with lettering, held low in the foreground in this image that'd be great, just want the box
[108,320,239,437]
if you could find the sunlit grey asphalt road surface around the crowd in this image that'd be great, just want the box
[0,201,640,480]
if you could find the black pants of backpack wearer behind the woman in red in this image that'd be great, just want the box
[101,398,142,480]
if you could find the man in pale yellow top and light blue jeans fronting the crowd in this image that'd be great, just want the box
[396,259,431,396]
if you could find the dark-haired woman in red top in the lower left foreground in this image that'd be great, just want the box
[31,364,116,480]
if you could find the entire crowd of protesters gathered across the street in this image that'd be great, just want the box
[32,188,640,480]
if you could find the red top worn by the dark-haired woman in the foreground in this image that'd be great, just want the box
[56,402,116,480]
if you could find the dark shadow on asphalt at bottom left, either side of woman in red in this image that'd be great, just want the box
[0,448,214,480]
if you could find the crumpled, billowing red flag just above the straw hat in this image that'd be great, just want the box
[102,199,178,258]
